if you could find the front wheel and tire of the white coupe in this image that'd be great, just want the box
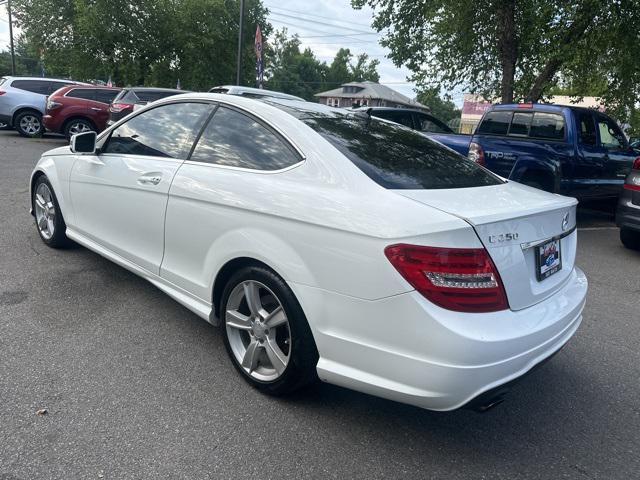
[31,175,72,248]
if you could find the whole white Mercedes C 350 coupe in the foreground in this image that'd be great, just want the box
[30,93,587,410]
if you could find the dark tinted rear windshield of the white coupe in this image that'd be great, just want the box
[299,113,502,190]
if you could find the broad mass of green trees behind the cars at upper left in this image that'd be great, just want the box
[13,0,270,90]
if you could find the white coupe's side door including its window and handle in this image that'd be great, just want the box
[69,102,213,274]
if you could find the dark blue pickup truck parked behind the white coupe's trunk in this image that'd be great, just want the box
[469,104,638,200]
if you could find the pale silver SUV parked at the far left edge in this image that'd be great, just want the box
[0,77,88,137]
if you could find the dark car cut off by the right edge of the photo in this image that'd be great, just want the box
[616,157,640,250]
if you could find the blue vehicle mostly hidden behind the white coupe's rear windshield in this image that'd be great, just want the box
[353,107,471,156]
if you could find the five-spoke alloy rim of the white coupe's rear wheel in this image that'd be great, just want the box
[225,280,291,382]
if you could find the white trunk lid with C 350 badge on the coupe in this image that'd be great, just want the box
[395,182,577,310]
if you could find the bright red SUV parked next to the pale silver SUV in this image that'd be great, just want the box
[42,85,121,139]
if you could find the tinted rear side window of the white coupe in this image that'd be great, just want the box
[190,107,300,170]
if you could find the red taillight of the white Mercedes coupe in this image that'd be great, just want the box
[384,244,509,313]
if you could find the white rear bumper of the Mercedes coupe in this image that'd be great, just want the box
[292,268,587,411]
